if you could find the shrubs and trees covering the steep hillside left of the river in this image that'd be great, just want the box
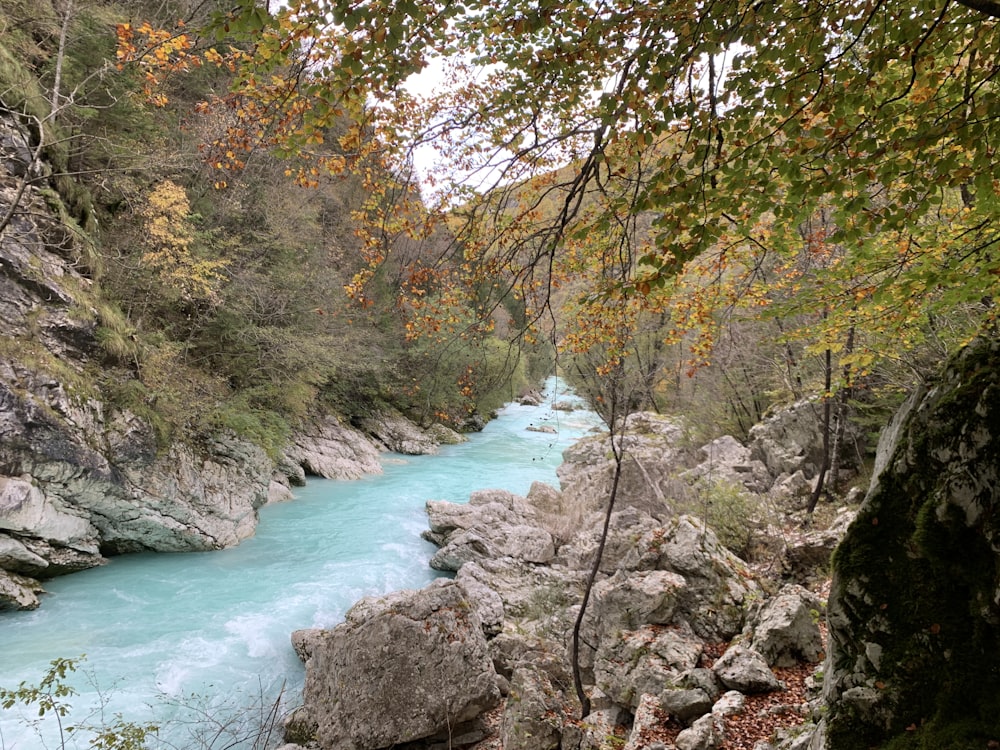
[0,0,544,458]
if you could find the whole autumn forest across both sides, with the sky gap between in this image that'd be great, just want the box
[2,0,998,470]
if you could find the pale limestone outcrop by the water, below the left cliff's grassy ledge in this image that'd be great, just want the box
[0,370,272,574]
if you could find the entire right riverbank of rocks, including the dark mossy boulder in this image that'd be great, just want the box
[276,338,1000,750]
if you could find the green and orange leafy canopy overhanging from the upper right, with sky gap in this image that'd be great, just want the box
[119,0,1000,406]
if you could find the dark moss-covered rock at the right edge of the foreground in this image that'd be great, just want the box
[824,338,1000,750]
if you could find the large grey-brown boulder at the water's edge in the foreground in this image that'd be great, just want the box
[289,580,500,750]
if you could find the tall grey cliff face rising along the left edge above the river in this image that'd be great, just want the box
[0,110,274,608]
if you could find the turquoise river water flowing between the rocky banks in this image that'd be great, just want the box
[0,379,597,750]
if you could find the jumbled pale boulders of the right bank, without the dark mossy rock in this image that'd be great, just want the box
[286,414,844,750]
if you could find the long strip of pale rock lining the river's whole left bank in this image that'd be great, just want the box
[0,390,462,609]
